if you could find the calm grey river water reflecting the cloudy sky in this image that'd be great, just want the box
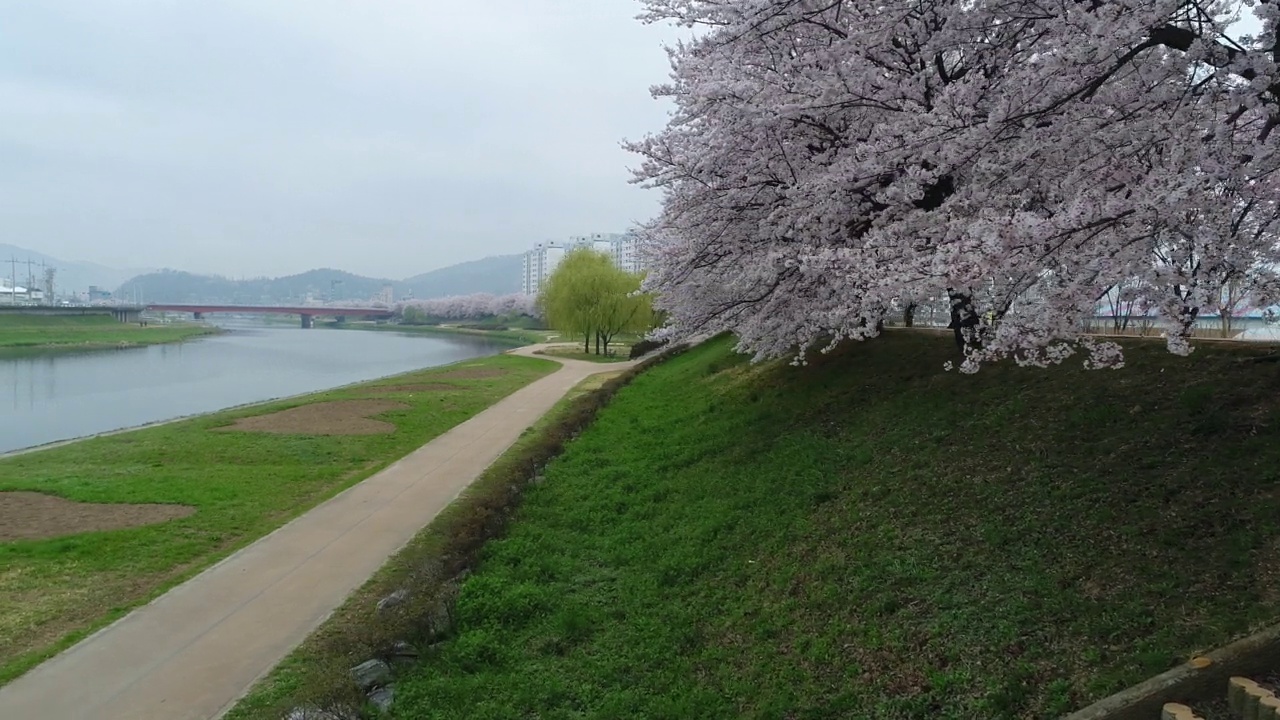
[0,325,504,454]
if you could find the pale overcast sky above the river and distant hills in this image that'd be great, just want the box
[0,0,676,278]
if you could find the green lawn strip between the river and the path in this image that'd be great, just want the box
[0,355,558,682]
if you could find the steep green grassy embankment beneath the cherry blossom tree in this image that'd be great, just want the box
[392,332,1280,720]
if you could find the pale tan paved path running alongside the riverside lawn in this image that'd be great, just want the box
[0,346,631,720]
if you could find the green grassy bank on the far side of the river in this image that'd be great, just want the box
[0,313,218,348]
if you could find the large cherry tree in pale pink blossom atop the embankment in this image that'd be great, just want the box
[628,0,1280,372]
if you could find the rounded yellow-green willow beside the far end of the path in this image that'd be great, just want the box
[538,249,653,355]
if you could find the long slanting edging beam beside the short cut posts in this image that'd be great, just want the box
[1064,625,1280,720]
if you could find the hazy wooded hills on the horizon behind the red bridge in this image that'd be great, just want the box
[118,255,521,305]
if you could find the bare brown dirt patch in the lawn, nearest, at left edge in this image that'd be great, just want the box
[0,492,196,542]
